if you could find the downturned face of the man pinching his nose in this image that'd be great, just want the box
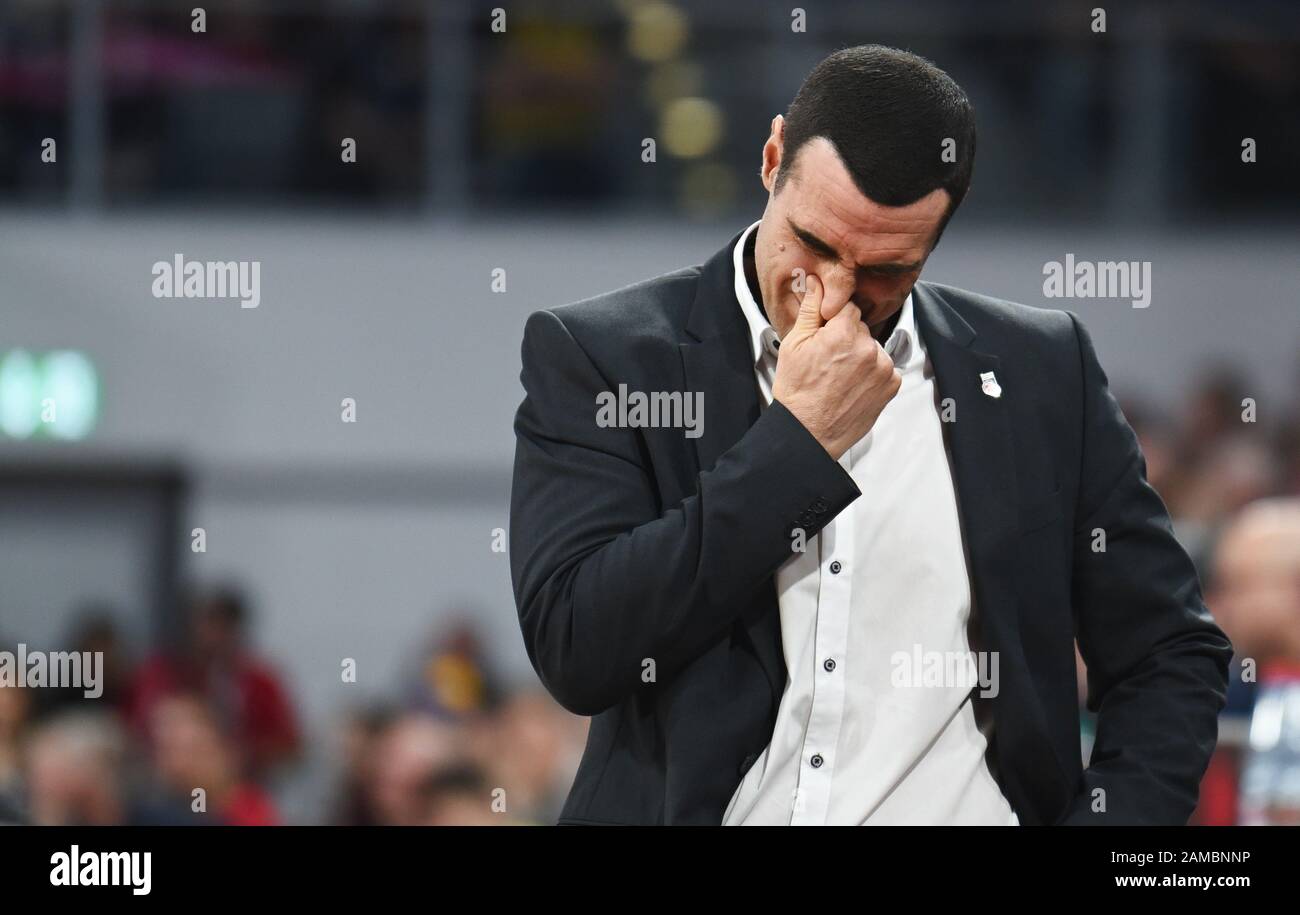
[754,116,949,337]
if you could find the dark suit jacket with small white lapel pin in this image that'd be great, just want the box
[511,235,1231,824]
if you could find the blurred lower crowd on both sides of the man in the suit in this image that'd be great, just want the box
[0,372,1300,825]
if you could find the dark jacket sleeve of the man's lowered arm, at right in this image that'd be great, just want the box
[1063,313,1232,825]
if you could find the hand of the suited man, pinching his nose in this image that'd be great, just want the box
[772,274,902,460]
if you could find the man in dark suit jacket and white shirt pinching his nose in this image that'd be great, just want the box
[511,45,1231,824]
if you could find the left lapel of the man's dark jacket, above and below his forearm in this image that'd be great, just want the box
[680,233,785,708]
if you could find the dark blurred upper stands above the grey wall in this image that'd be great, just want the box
[0,0,1300,224]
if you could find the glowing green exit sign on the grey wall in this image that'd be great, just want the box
[0,350,99,441]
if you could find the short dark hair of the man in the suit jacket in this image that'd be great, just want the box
[774,44,975,242]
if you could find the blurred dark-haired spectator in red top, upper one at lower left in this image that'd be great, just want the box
[129,589,300,776]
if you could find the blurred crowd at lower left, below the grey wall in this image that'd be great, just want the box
[0,589,586,825]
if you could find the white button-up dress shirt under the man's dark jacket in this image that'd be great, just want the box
[723,222,1018,825]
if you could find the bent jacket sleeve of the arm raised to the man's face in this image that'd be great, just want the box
[510,312,859,715]
